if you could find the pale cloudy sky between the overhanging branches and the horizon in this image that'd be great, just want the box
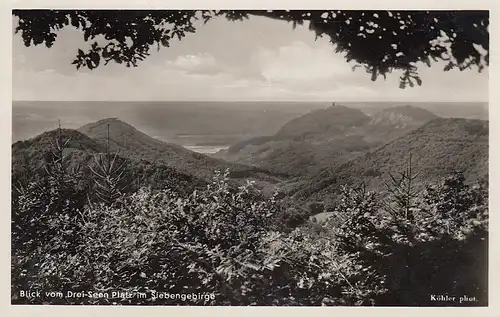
[13,13,488,101]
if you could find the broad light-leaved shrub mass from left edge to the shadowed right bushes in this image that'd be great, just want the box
[13,168,378,305]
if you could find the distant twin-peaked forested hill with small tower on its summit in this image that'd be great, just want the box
[216,105,438,176]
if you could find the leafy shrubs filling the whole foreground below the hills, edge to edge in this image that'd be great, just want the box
[13,159,487,306]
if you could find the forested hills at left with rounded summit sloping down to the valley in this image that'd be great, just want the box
[12,118,283,195]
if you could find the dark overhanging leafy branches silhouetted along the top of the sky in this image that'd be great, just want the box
[13,10,489,88]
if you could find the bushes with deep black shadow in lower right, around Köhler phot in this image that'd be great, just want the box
[324,170,488,306]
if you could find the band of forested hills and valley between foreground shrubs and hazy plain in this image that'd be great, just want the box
[13,103,488,215]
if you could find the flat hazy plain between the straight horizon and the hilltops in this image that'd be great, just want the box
[12,101,489,153]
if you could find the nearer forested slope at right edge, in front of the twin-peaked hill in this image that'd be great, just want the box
[295,118,488,199]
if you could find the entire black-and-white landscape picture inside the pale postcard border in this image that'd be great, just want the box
[9,8,491,307]
